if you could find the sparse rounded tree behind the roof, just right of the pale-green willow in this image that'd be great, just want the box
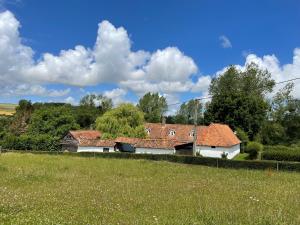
[137,92,168,123]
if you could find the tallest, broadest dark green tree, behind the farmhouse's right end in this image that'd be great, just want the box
[205,64,275,140]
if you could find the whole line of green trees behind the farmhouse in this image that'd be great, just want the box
[0,64,300,149]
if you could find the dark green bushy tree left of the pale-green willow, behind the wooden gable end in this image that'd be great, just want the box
[28,105,80,138]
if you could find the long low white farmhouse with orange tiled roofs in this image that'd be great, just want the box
[62,123,241,159]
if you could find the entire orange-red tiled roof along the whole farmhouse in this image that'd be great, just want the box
[70,123,241,149]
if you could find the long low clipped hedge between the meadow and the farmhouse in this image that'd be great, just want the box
[2,151,300,172]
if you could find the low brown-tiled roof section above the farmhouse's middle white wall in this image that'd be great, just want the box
[135,139,176,149]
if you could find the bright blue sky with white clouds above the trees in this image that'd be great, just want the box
[0,0,300,110]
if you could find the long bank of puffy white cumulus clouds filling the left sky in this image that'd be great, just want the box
[0,11,202,98]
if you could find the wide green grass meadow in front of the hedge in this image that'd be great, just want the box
[0,153,300,225]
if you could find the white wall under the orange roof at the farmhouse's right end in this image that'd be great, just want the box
[197,144,240,159]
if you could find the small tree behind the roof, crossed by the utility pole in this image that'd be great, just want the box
[175,100,202,124]
